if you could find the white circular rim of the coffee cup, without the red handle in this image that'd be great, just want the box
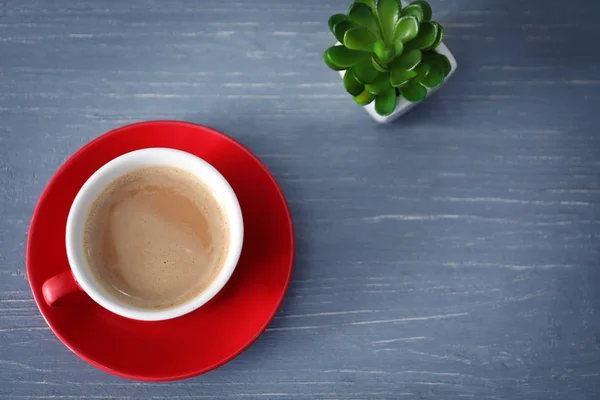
[65,147,244,321]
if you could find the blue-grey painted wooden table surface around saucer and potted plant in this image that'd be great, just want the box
[0,0,600,400]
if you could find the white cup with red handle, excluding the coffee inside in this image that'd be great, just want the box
[42,148,244,321]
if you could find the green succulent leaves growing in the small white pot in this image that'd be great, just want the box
[323,0,450,116]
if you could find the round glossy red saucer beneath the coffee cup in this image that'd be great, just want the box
[27,121,294,381]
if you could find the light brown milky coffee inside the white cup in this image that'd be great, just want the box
[83,167,229,309]
